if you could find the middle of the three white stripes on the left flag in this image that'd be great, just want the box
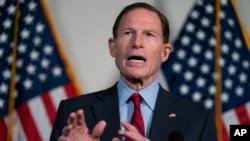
[28,96,51,141]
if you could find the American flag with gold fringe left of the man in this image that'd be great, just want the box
[0,0,80,141]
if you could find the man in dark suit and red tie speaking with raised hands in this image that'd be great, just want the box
[50,3,217,141]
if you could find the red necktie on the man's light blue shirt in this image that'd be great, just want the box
[126,93,145,141]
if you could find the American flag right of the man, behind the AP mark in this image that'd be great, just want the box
[162,0,250,141]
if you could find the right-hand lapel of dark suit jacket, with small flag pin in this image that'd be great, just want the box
[149,87,178,141]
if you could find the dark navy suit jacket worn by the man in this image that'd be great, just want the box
[50,85,217,141]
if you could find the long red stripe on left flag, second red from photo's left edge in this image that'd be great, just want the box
[17,104,41,141]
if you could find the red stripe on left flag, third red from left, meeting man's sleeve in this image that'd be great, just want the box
[41,93,56,126]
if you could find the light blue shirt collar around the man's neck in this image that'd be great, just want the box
[117,78,159,110]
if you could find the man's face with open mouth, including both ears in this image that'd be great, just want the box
[109,8,171,81]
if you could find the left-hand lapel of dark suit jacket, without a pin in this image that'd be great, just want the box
[92,85,120,140]
